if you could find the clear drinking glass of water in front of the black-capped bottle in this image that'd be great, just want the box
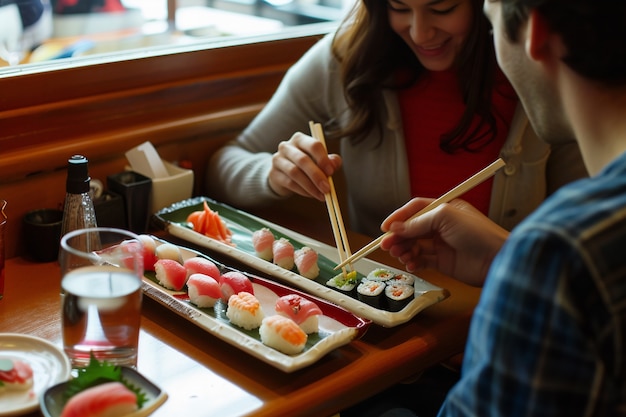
[59,227,143,367]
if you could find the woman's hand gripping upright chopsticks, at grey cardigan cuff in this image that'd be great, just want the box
[268,132,341,201]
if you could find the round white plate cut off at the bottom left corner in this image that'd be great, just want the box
[0,333,72,417]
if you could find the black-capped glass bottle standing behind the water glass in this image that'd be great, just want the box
[62,155,97,236]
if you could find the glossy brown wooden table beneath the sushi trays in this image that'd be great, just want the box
[0,230,479,417]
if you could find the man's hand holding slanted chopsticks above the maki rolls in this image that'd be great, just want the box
[380,198,508,286]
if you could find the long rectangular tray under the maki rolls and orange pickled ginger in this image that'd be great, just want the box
[155,197,449,327]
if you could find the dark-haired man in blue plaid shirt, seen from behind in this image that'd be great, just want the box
[382,0,626,417]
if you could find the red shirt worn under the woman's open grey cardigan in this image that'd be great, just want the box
[398,71,517,214]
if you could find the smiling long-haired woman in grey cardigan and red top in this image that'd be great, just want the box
[207,0,585,236]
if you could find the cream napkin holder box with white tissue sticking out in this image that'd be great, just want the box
[150,161,193,213]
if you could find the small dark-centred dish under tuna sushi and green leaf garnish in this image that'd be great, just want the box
[40,367,167,417]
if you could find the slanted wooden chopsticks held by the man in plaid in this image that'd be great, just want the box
[334,158,504,269]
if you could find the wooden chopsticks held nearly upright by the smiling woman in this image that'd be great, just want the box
[309,121,352,275]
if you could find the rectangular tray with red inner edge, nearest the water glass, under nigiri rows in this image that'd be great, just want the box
[142,242,371,372]
